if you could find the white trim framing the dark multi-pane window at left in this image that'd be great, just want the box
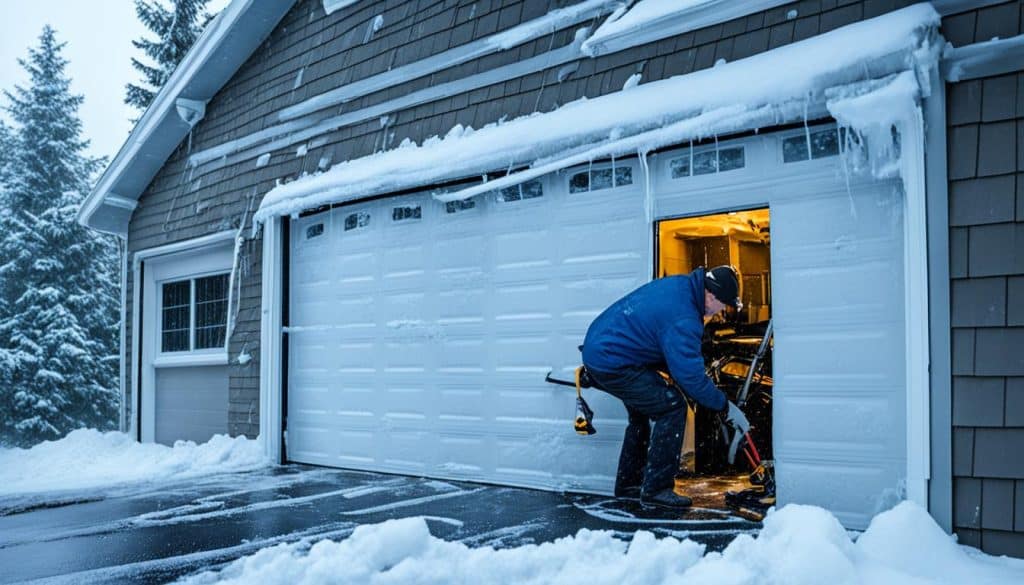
[131,232,236,443]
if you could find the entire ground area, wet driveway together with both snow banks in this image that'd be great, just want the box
[0,431,1024,585]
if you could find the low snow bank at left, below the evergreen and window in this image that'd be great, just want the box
[0,429,270,496]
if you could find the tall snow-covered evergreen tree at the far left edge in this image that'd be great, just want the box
[0,27,120,446]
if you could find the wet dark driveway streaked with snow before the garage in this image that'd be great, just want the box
[0,465,760,583]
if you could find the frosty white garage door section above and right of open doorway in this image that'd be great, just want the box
[651,127,907,529]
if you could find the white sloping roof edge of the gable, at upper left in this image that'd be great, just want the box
[78,0,295,235]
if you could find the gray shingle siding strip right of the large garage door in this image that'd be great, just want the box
[942,1,1024,556]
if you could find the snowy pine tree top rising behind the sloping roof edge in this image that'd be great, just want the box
[125,0,210,111]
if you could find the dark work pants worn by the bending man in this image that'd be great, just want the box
[588,368,686,496]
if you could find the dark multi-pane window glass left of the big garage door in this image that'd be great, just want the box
[160,274,228,352]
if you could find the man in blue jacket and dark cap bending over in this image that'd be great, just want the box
[583,266,750,508]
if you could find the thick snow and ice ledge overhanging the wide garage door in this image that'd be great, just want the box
[255,4,940,227]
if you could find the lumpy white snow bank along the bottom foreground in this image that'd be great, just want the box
[179,502,1024,585]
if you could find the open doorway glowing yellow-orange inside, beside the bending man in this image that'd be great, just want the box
[654,208,774,515]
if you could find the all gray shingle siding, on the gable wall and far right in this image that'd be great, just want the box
[126,0,1024,555]
